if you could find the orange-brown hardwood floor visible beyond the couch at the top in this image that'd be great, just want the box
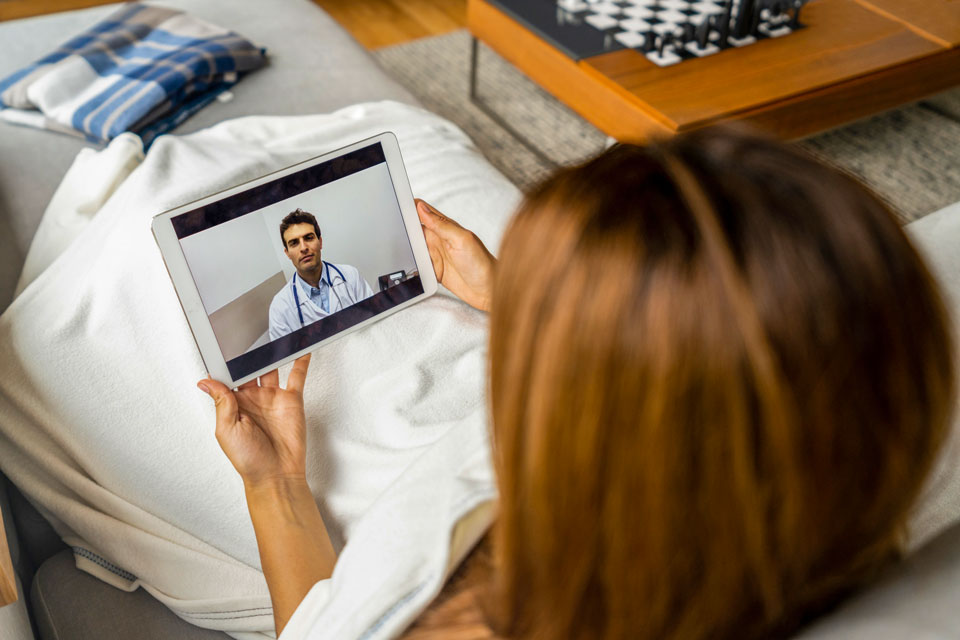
[0,0,467,49]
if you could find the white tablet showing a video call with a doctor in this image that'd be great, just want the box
[153,133,437,387]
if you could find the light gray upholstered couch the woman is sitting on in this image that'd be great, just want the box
[0,0,960,640]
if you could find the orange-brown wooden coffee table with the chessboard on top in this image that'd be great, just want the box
[467,0,960,141]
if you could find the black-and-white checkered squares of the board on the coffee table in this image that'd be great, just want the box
[557,0,794,67]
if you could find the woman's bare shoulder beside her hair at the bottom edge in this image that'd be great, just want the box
[401,535,503,640]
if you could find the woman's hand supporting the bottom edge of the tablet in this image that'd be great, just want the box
[197,354,310,489]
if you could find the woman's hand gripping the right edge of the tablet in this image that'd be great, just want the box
[416,198,497,311]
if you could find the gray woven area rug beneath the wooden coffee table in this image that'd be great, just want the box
[374,30,960,223]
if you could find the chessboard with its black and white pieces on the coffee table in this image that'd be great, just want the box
[555,0,807,67]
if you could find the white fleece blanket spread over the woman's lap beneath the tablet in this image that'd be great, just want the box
[0,103,519,638]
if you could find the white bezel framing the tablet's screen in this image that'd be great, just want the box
[151,131,437,388]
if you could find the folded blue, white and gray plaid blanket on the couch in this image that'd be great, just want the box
[0,3,266,146]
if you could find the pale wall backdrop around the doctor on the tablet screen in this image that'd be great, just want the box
[180,163,416,360]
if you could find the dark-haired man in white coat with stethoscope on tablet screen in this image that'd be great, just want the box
[270,209,373,340]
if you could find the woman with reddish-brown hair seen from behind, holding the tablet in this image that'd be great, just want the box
[201,130,954,639]
